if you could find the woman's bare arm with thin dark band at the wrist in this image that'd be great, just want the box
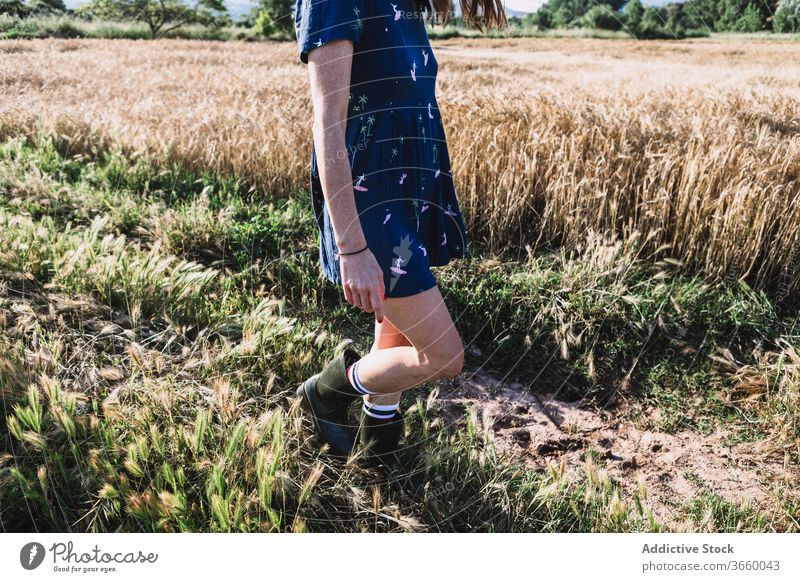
[308,40,384,321]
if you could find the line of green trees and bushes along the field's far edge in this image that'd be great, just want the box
[0,0,800,38]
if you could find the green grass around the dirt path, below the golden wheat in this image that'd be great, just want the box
[0,137,800,531]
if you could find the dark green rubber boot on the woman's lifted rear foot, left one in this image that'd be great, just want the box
[297,348,362,457]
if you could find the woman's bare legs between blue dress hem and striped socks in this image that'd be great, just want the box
[358,286,464,404]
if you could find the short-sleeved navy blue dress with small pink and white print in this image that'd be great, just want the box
[295,0,471,297]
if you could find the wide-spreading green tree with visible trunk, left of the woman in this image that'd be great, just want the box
[79,0,228,37]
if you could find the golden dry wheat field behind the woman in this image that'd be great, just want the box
[0,39,800,293]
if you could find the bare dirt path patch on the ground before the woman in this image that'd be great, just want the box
[433,371,800,530]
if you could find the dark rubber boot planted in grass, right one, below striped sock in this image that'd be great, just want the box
[359,409,425,497]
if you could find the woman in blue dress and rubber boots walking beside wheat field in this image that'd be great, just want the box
[295,0,506,489]
